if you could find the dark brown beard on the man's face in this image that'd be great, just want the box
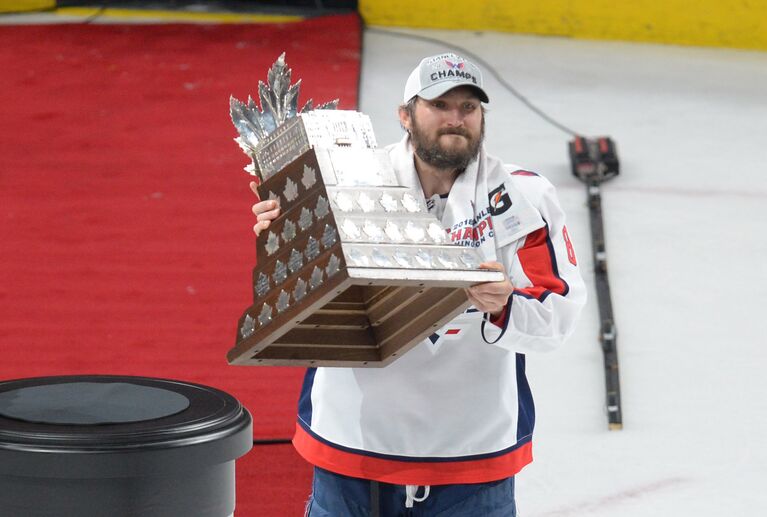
[410,113,485,173]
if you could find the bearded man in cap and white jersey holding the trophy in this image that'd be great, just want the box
[253,53,586,517]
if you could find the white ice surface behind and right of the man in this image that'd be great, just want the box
[360,27,767,517]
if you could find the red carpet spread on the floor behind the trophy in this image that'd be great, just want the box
[0,15,360,517]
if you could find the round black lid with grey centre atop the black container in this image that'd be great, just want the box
[0,375,252,477]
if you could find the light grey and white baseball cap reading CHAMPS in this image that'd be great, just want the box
[404,52,489,102]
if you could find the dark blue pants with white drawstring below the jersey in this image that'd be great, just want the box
[307,467,517,517]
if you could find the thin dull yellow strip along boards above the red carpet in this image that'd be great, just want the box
[56,7,304,23]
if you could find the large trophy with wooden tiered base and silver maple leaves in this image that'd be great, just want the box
[227,54,503,366]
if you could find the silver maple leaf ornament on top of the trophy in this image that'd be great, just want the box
[229,52,338,183]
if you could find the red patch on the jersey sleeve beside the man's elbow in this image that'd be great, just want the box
[514,226,569,301]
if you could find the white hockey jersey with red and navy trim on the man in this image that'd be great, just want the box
[293,137,586,485]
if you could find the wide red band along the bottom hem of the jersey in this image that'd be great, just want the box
[293,425,533,485]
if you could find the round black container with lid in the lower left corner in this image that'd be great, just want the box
[0,375,253,517]
